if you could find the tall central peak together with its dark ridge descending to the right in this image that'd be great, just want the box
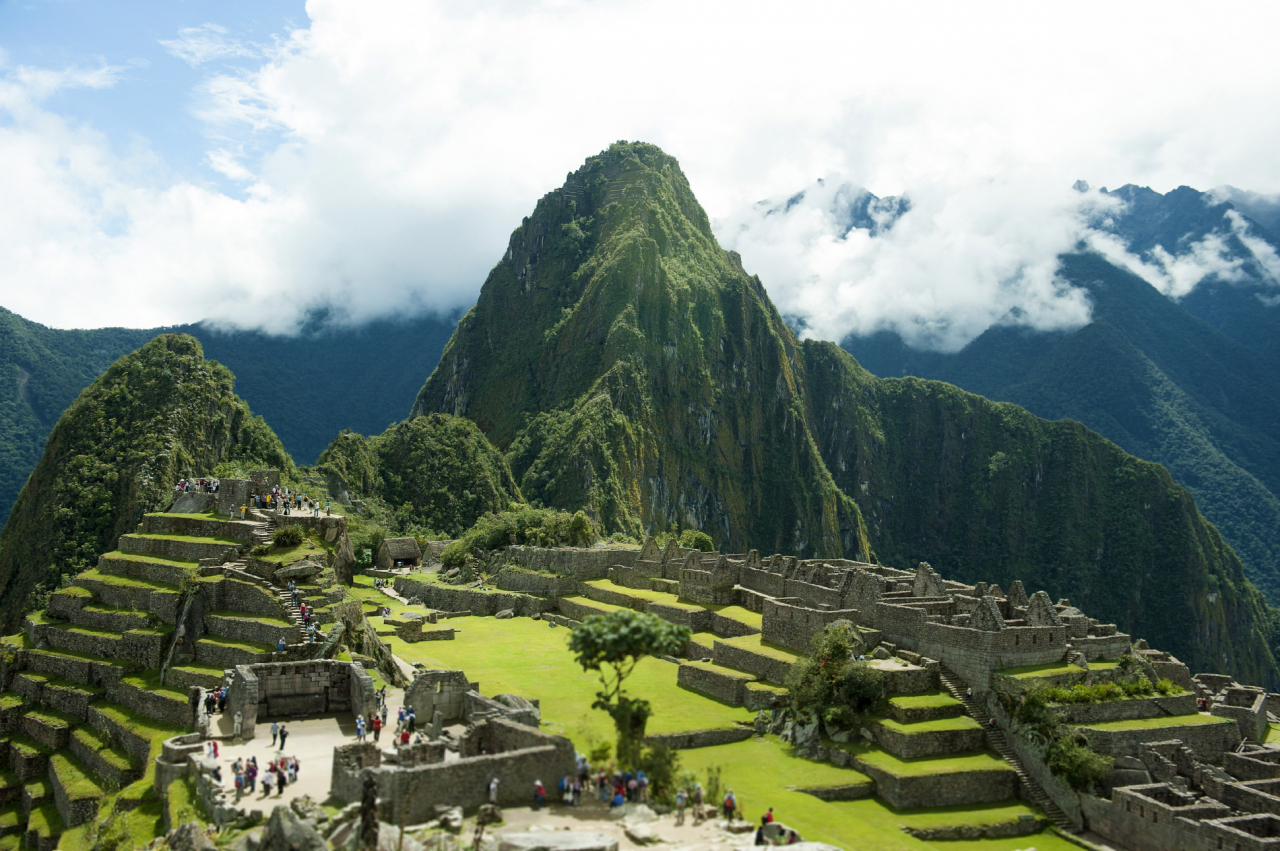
[413,143,1280,686]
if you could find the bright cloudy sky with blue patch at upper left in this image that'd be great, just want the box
[0,0,1280,351]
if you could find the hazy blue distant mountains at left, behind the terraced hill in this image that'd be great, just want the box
[0,307,457,521]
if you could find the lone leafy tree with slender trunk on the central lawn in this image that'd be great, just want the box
[568,609,690,767]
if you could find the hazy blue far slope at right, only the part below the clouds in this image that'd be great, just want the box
[844,253,1280,601]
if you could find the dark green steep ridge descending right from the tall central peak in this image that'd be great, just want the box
[804,342,1276,683]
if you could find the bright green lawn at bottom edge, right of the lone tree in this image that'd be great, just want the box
[680,736,1076,851]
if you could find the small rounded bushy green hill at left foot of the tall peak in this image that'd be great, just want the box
[317,413,524,537]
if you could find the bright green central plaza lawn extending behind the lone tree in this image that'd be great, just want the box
[385,617,754,750]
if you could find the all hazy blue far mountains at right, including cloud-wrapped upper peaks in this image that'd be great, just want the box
[841,186,1280,603]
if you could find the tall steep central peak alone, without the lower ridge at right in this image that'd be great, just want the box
[413,145,869,558]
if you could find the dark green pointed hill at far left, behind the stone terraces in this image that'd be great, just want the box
[0,334,293,631]
